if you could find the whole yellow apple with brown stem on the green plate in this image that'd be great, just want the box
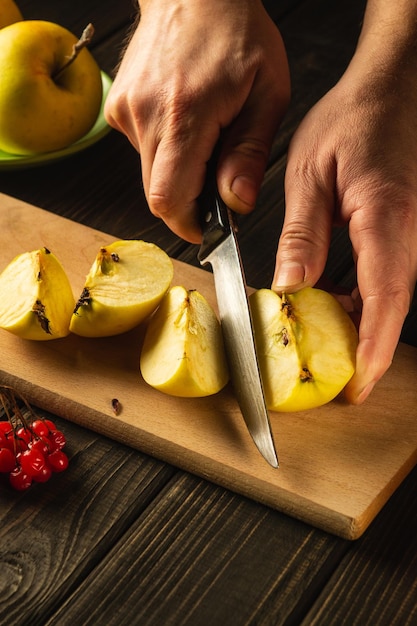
[0,20,102,155]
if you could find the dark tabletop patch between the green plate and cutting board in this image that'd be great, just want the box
[0,131,186,256]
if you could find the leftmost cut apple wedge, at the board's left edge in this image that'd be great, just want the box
[0,248,75,340]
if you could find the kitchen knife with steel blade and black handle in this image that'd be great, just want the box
[198,175,278,468]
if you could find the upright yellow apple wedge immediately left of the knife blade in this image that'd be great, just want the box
[140,286,229,397]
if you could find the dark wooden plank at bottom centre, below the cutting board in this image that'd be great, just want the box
[44,474,349,626]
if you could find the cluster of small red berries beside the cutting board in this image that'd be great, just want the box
[0,387,68,491]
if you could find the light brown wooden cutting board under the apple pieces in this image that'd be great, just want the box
[0,194,417,539]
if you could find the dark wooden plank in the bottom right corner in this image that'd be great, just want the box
[303,460,417,626]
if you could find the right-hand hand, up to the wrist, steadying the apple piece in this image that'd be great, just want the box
[272,62,417,404]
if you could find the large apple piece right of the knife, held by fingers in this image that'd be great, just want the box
[250,287,358,411]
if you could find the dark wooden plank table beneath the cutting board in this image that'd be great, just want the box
[0,0,417,626]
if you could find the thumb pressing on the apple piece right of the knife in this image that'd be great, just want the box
[272,157,334,292]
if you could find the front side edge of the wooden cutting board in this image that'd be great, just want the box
[0,371,394,541]
